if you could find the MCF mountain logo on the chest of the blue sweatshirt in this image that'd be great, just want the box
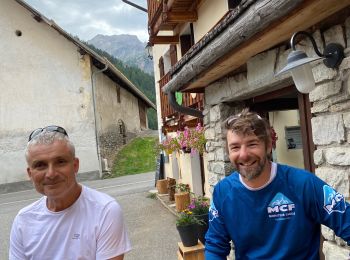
[267,192,295,220]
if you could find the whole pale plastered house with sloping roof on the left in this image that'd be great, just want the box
[0,0,156,190]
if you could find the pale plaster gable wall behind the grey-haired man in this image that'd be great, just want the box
[0,0,99,184]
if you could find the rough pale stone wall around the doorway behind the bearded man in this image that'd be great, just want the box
[204,17,350,259]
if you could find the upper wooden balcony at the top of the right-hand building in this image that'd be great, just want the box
[147,0,200,44]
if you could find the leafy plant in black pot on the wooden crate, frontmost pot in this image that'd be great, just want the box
[176,209,203,247]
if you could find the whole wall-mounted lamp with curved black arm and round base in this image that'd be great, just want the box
[276,31,344,94]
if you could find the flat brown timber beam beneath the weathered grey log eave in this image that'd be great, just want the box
[186,0,350,90]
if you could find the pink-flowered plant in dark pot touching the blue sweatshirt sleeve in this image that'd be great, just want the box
[188,195,209,245]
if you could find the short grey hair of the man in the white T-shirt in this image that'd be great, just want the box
[25,130,75,162]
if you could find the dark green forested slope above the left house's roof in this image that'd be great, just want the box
[84,42,158,129]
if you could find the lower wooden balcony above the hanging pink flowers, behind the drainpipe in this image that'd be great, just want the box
[159,73,204,131]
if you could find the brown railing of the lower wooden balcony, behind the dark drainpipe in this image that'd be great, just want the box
[159,73,204,122]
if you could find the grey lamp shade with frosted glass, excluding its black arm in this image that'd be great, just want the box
[276,50,322,94]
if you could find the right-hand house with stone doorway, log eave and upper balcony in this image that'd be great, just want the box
[148,0,350,259]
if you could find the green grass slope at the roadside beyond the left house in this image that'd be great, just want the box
[109,137,158,178]
